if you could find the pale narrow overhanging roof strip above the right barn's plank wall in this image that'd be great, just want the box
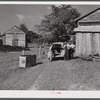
[74,25,100,33]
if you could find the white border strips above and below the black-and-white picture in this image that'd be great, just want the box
[0,1,100,98]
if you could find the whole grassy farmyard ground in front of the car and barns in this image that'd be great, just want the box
[0,48,100,90]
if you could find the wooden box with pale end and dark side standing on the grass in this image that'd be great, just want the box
[19,55,36,68]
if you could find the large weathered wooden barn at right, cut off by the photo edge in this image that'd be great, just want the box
[74,8,100,57]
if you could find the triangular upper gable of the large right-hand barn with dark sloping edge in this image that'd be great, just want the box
[75,8,100,22]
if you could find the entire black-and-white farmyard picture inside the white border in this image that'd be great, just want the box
[0,3,100,90]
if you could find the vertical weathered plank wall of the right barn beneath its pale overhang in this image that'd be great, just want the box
[75,33,100,56]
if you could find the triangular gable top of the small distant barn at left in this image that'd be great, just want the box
[4,26,25,34]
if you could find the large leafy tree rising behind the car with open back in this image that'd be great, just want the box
[37,5,80,41]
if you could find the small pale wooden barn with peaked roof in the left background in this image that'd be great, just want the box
[1,26,27,47]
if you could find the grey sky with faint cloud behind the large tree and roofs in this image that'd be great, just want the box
[0,5,100,33]
